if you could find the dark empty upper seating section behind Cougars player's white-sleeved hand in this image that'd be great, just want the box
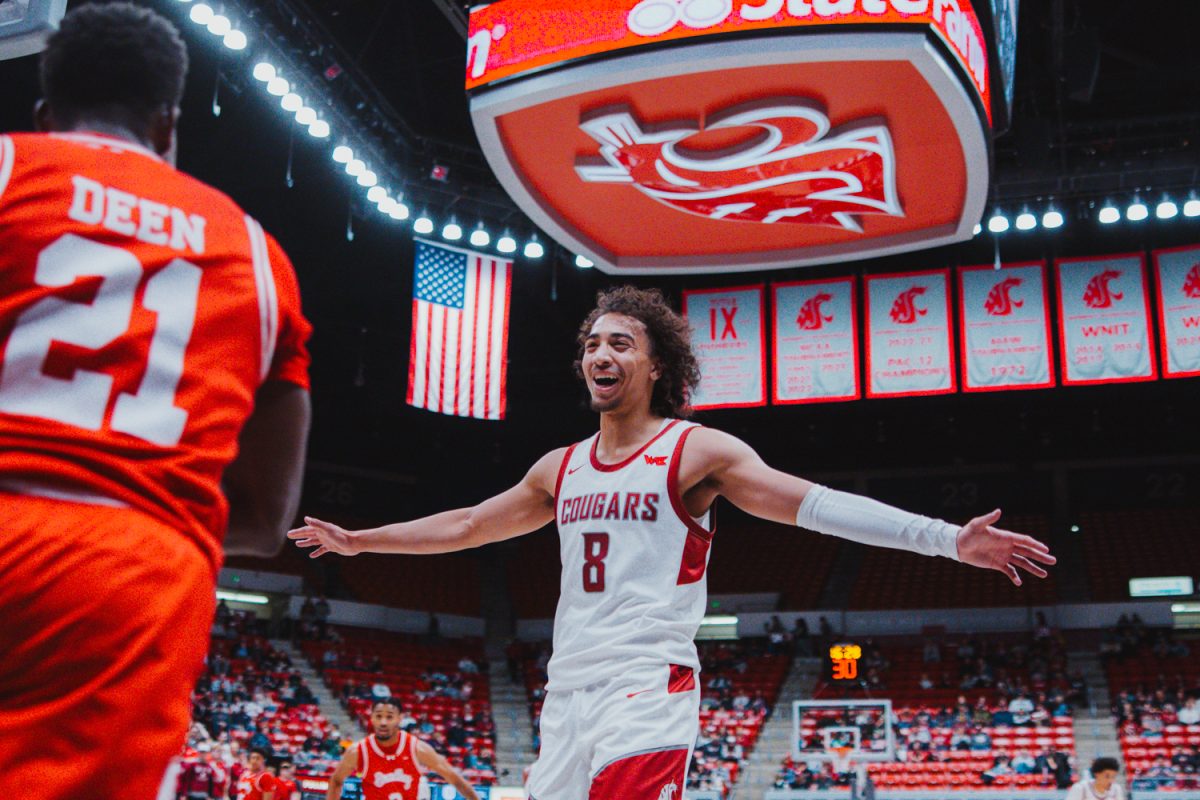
[850,515,1057,610]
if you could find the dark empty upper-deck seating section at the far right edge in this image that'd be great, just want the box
[1079,509,1200,601]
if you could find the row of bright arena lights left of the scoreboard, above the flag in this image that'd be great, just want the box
[180,0,549,260]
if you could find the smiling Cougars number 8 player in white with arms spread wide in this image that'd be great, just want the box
[288,287,1055,800]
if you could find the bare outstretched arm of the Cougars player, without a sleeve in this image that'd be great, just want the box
[288,447,566,558]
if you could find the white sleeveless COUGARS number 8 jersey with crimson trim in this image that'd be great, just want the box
[547,420,713,691]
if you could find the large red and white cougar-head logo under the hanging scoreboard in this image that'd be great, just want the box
[575,98,904,233]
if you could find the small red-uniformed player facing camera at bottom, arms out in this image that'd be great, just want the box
[325,700,479,800]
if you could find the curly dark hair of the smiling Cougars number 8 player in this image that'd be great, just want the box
[575,285,700,419]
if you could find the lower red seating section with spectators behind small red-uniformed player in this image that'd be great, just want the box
[300,627,496,784]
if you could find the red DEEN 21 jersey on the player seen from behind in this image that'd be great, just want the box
[0,133,310,569]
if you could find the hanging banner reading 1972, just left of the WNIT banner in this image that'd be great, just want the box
[959,261,1054,392]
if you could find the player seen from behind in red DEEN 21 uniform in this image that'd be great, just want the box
[0,4,310,800]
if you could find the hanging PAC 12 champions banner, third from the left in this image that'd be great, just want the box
[866,270,955,397]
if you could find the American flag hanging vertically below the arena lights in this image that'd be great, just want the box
[408,239,512,420]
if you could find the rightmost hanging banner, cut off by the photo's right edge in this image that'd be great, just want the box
[1154,246,1200,378]
